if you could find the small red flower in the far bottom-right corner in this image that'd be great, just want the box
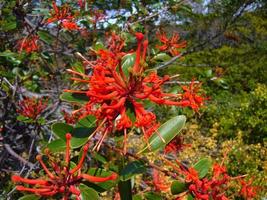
[239,179,258,200]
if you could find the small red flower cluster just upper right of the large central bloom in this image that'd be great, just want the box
[157,32,186,56]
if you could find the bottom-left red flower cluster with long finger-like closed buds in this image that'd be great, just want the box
[12,133,117,200]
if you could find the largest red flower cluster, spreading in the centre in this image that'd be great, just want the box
[65,33,204,152]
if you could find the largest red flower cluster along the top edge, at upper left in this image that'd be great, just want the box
[46,1,79,30]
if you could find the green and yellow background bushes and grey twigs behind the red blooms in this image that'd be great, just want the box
[0,0,267,199]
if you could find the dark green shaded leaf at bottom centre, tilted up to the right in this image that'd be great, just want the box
[120,161,146,181]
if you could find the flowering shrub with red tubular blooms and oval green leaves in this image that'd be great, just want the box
[0,0,264,200]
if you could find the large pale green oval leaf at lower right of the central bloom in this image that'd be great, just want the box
[139,115,186,153]
